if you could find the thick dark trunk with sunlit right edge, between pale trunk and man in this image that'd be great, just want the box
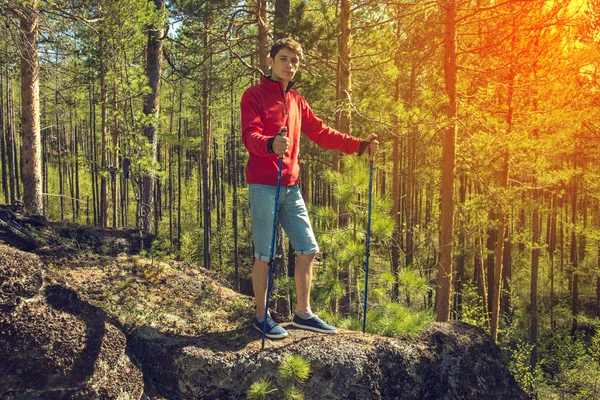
[138,0,164,233]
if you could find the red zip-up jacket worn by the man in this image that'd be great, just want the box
[240,77,360,186]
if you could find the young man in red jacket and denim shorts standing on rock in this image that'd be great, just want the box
[240,38,379,339]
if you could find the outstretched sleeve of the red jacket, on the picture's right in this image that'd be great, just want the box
[301,98,360,154]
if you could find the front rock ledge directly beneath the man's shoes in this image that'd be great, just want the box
[130,322,526,400]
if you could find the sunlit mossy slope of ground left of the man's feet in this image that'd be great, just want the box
[38,241,253,336]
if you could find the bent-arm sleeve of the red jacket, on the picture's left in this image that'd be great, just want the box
[240,90,270,156]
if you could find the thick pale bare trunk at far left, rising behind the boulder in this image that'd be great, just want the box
[19,0,44,214]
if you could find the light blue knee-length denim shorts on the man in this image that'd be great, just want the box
[248,184,319,261]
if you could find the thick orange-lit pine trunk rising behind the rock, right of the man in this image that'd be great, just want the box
[436,0,457,322]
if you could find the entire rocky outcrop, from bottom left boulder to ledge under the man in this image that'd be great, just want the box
[0,241,526,400]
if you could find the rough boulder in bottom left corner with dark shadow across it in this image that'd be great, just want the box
[0,245,144,400]
